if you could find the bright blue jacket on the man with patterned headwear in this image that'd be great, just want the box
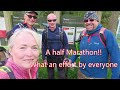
[70,24,120,78]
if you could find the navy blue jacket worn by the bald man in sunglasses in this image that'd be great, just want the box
[42,26,68,60]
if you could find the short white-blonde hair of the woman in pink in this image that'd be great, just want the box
[8,28,41,50]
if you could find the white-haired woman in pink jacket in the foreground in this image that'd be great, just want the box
[0,28,41,79]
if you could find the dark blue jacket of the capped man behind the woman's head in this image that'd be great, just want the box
[7,22,37,39]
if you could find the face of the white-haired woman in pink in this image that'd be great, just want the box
[10,33,39,69]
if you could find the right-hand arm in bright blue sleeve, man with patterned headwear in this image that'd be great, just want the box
[105,30,120,79]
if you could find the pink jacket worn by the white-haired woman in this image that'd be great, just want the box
[0,58,38,79]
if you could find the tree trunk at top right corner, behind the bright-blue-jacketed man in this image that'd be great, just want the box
[108,11,120,34]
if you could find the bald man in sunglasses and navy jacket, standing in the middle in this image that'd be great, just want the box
[42,13,68,79]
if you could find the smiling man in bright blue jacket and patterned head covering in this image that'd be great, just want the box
[70,11,120,79]
